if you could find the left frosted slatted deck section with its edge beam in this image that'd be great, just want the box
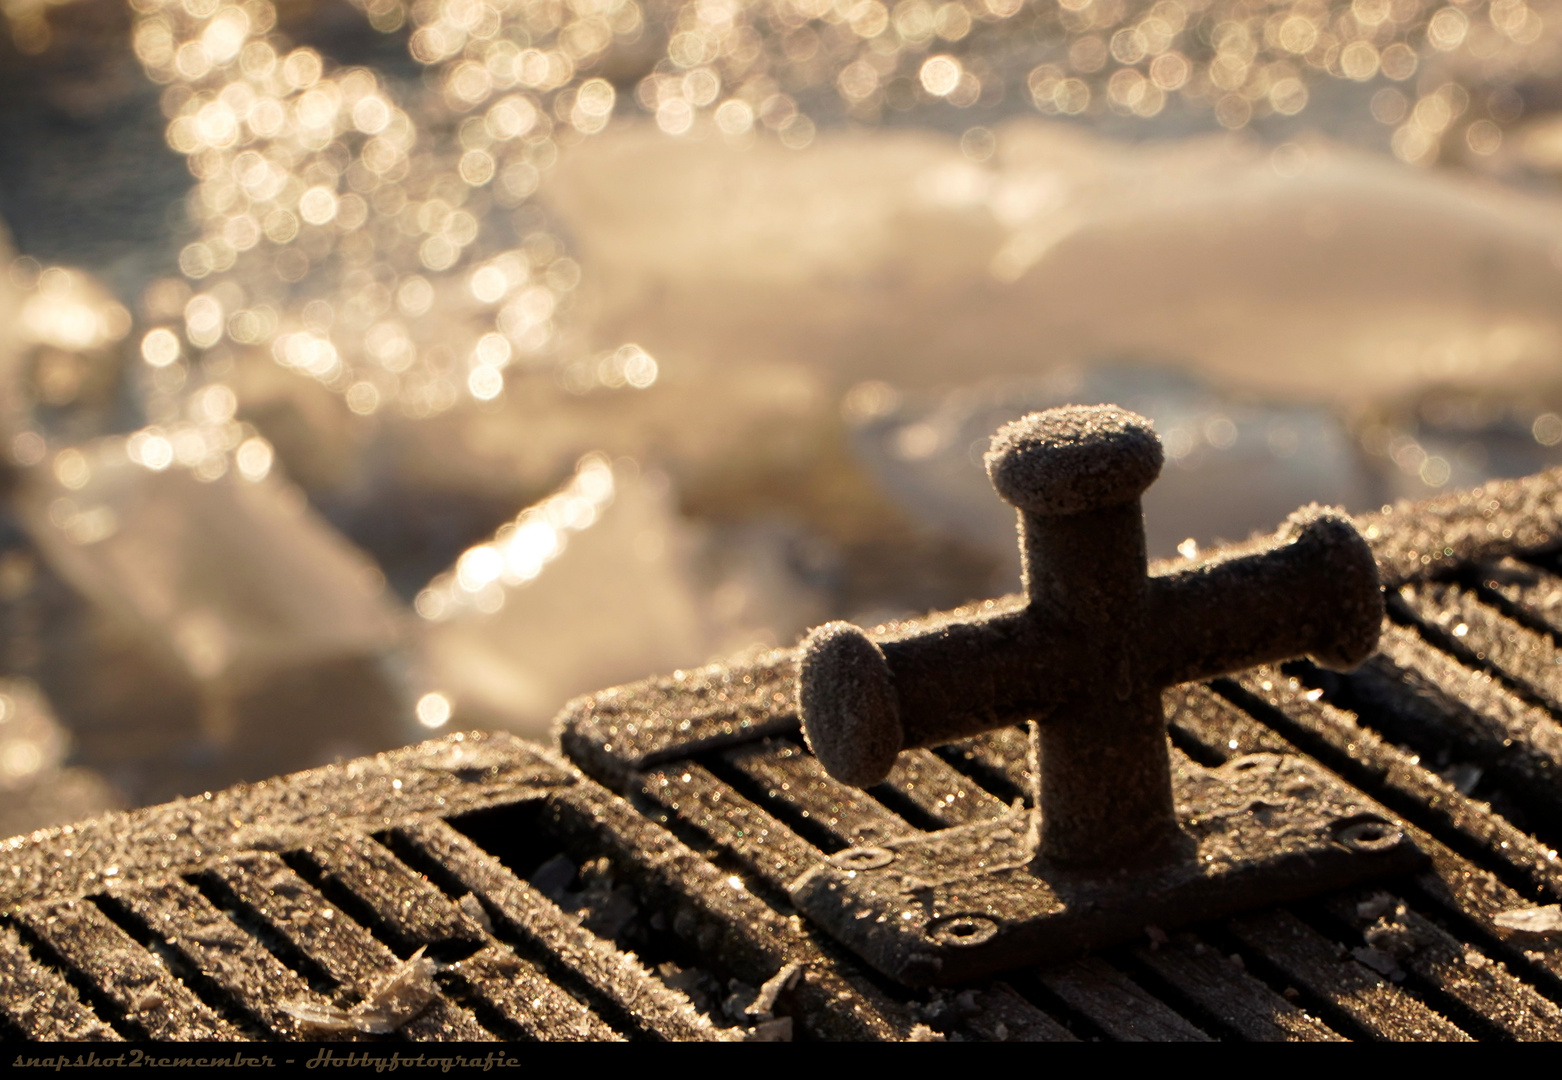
[0,736,740,1039]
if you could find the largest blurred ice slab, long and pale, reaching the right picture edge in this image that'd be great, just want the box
[544,120,1562,400]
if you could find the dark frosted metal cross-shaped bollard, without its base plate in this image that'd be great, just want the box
[798,405,1384,866]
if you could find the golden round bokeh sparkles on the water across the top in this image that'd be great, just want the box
[60,0,1557,462]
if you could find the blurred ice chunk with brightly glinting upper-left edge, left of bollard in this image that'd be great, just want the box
[419,455,825,735]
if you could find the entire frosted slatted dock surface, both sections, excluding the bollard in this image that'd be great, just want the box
[9,477,1562,1041]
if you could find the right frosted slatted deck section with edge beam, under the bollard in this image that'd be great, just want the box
[561,475,1562,1039]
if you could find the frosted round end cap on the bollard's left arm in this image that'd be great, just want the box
[797,622,904,788]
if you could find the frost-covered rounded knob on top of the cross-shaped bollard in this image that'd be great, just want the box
[986,405,1165,517]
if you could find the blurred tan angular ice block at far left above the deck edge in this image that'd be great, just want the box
[16,439,414,802]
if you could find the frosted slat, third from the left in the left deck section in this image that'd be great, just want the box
[109,878,325,1038]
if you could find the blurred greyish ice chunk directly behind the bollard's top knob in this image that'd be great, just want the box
[847,367,1378,568]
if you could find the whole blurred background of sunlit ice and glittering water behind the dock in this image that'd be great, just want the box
[0,0,1562,835]
